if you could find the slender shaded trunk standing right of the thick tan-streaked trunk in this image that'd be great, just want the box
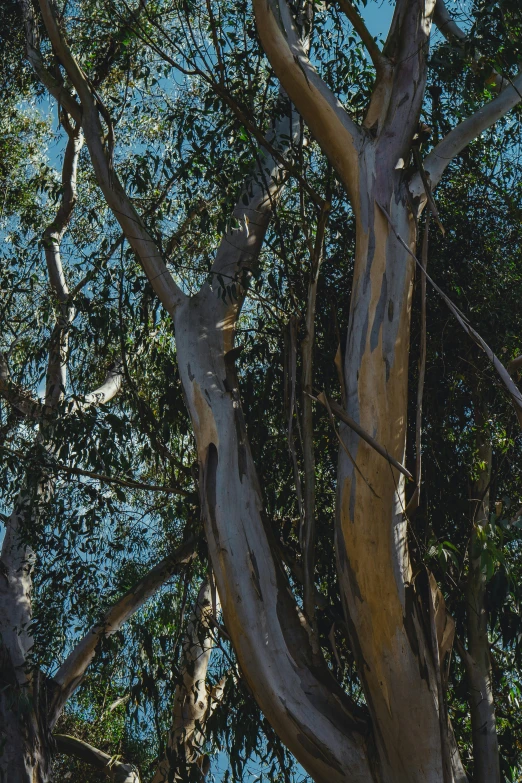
[463,405,500,783]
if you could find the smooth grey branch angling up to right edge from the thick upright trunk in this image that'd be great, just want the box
[410,72,522,199]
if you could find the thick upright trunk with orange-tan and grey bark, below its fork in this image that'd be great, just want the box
[337,153,460,783]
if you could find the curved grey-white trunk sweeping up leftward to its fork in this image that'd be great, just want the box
[175,287,378,783]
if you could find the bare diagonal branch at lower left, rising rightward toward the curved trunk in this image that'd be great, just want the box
[49,537,196,728]
